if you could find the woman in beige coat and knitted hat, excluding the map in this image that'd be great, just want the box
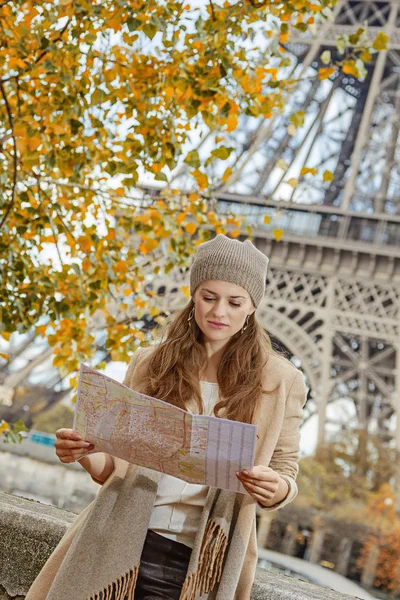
[27,234,306,600]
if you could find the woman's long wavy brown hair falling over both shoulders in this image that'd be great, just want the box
[138,299,281,423]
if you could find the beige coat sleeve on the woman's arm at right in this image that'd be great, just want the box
[257,370,307,511]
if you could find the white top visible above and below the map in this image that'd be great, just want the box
[149,381,219,548]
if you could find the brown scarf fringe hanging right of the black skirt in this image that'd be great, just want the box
[179,519,228,600]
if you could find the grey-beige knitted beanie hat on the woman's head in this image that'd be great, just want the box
[190,233,269,308]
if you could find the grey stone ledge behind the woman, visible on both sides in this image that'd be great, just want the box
[0,492,354,600]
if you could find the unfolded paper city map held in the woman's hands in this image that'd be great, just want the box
[73,365,257,494]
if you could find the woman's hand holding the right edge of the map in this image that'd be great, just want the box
[236,465,288,506]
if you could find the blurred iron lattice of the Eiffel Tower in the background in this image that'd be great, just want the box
[141,0,400,510]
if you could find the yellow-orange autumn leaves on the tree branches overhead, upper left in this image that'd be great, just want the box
[0,0,385,374]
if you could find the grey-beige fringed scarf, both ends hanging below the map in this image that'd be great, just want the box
[26,458,248,600]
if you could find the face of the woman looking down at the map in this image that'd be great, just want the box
[193,280,255,342]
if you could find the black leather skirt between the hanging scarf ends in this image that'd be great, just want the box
[120,529,192,600]
